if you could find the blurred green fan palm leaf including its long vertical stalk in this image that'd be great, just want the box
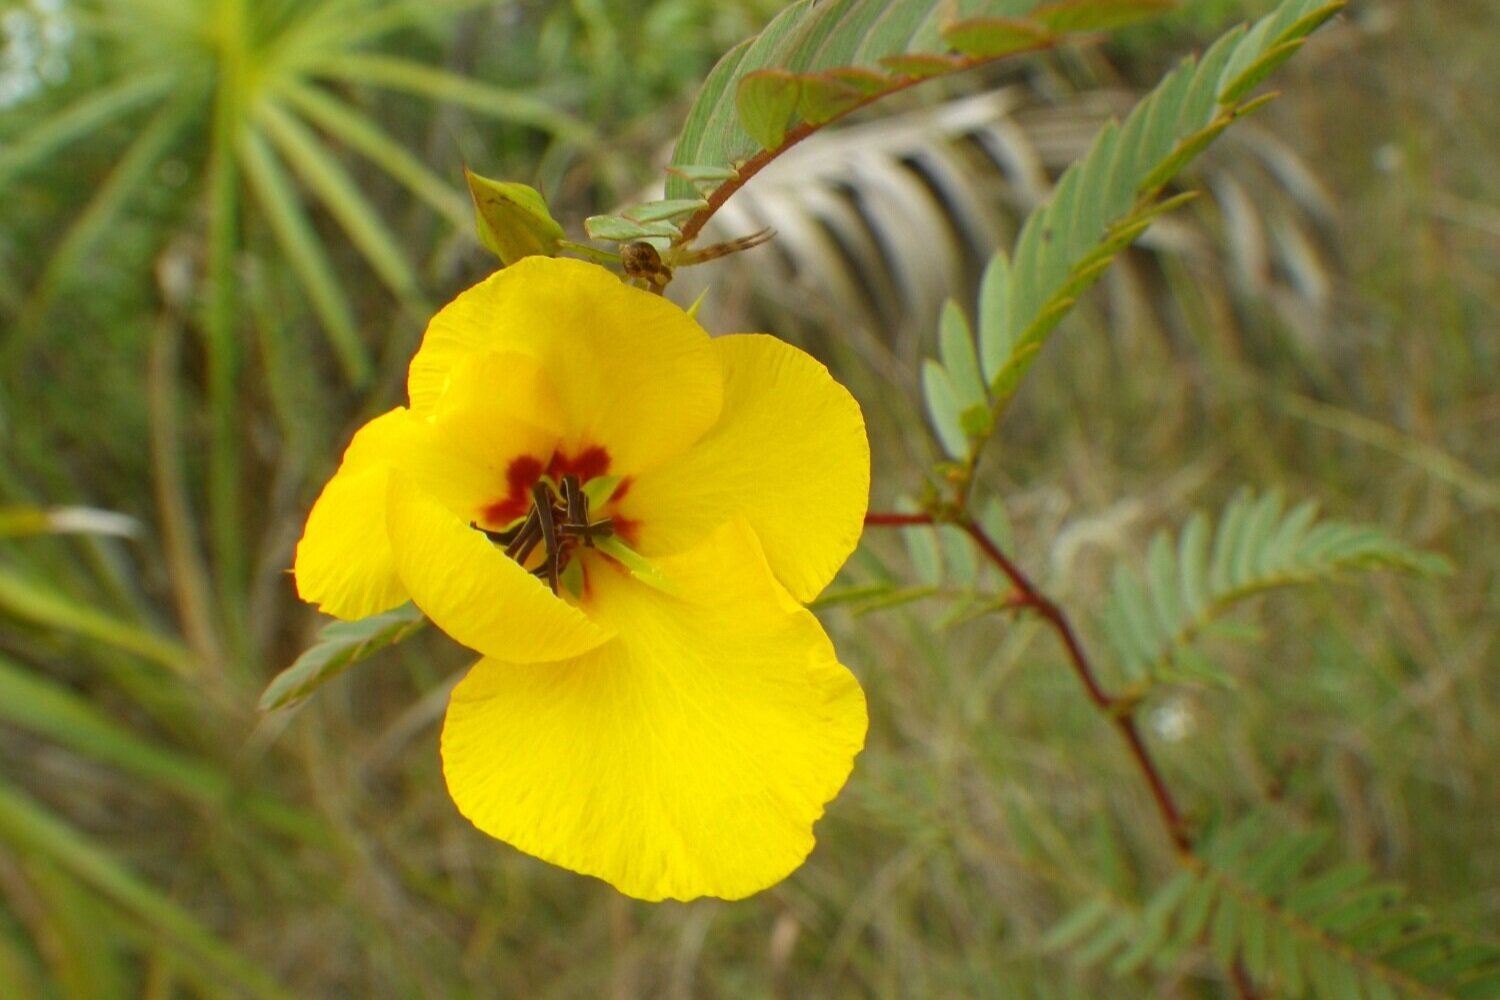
[0,0,590,680]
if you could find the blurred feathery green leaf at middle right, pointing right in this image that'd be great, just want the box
[1101,492,1451,684]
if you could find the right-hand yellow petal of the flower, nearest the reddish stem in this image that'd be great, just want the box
[618,334,870,601]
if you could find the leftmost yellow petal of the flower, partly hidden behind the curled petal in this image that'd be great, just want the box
[293,409,408,619]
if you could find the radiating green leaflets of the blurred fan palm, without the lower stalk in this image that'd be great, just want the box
[0,0,588,384]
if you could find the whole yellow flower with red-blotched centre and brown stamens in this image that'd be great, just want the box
[296,256,870,900]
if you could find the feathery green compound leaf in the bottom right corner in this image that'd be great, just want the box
[1046,814,1500,1000]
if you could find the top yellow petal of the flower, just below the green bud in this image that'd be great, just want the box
[407,256,723,475]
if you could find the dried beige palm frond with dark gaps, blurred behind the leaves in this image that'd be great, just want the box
[674,84,1332,384]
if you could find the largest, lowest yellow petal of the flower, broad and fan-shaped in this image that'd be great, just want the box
[443,522,866,900]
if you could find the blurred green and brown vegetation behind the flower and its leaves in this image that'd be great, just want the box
[0,0,1500,1000]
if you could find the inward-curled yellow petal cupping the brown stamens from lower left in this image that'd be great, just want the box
[386,474,612,663]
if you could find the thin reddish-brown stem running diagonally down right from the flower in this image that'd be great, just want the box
[864,513,1193,853]
